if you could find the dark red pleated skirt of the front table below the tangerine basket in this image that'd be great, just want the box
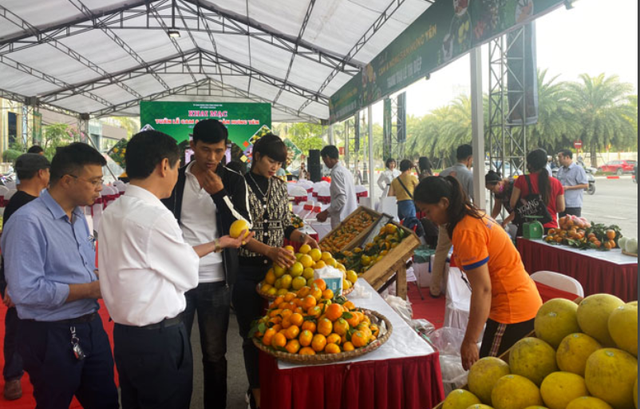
[260,352,444,409]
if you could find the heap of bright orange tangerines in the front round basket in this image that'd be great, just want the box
[253,279,380,355]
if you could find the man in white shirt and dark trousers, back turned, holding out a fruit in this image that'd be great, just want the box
[98,131,250,409]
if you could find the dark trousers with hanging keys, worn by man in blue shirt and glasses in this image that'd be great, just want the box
[18,315,119,409]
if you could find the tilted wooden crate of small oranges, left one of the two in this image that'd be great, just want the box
[319,206,382,254]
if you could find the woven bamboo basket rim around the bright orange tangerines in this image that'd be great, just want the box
[253,309,393,365]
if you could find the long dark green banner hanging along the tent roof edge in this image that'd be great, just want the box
[329,0,564,123]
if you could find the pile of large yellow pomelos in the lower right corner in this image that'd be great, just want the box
[443,294,638,409]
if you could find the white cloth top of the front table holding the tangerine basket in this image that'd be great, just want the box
[278,279,434,369]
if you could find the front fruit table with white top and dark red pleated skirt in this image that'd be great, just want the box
[260,280,444,409]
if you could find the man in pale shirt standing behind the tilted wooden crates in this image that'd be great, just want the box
[317,145,358,229]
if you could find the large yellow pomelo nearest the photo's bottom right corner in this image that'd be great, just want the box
[584,348,638,409]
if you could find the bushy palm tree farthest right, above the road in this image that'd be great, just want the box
[567,74,637,167]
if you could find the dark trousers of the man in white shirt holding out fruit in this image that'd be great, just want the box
[113,322,193,409]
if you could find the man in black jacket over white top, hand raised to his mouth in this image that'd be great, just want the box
[163,119,251,409]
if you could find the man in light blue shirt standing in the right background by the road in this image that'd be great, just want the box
[556,149,589,217]
